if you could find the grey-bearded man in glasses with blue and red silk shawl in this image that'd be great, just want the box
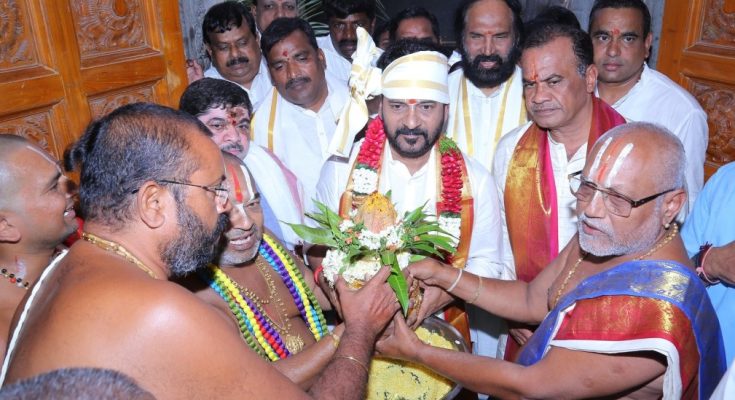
[382,123,726,399]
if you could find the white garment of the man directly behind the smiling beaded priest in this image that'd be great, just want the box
[243,143,304,250]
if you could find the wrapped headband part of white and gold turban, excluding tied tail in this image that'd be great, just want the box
[381,51,449,104]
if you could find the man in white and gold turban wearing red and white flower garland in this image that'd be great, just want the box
[317,40,504,357]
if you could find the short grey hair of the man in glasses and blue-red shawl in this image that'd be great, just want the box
[597,122,687,190]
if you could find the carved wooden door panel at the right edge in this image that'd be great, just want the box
[658,0,735,177]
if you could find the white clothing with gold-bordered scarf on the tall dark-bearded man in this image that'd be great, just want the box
[447,67,526,170]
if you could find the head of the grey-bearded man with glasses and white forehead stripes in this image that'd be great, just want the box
[572,122,686,257]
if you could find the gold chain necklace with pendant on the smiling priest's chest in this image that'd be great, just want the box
[222,257,306,354]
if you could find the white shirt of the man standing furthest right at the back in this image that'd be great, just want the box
[600,65,709,217]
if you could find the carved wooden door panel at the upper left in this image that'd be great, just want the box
[0,0,186,161]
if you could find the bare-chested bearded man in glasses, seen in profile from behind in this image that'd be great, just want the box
[0,103,399,399]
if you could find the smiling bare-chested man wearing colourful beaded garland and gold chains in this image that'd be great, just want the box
[182,153,344,388]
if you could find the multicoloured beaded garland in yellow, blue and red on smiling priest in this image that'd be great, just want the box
[200,234,329,361]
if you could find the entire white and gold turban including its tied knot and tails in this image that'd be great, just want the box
[328,28,449,157]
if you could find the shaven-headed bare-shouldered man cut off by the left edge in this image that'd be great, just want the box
[0,134,77,357]
